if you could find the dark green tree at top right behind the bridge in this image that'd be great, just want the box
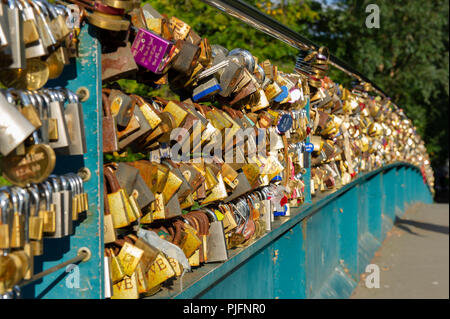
[308,0,449,167]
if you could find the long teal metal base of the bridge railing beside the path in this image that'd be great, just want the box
[150,163,432,299]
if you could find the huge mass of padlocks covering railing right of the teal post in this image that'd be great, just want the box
[83,1,433,298]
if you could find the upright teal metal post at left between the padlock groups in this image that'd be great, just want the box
[23,25,104,299]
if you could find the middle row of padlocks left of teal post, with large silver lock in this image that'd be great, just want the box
[0,89,87,186]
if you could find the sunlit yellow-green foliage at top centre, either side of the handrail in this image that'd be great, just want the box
[143,0,318,71]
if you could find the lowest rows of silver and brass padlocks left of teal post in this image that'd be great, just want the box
[0,173,89,293]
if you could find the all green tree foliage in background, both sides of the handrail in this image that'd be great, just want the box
[138,0,449,169]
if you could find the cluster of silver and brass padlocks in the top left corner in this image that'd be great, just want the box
[0,0,80,90]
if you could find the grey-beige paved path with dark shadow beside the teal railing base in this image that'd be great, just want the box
[351,204,449,299]
